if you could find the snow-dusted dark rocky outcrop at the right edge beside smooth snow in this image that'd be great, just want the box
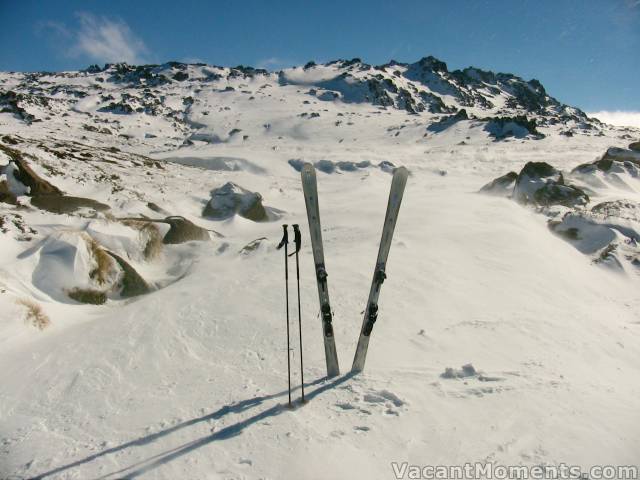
[480,148,640,271]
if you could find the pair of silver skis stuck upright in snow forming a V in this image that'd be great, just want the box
[302,163,409,377]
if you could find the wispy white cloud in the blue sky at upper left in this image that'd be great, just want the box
[68,13,148,64]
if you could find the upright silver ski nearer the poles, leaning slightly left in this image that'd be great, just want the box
[301,163,340,377]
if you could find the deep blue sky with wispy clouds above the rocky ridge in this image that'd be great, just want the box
[0,0,640,126]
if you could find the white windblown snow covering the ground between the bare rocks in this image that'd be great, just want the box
[0,62,640,479]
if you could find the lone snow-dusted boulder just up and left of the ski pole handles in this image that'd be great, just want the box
[202,182,270,222]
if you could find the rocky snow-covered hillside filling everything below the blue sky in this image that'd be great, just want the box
[0,57,640,479]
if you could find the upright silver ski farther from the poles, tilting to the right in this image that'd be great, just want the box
[351,167,409,373]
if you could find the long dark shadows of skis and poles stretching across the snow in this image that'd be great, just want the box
[28,373,353,480]
